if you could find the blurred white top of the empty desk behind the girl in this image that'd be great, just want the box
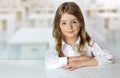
[8,27,52,44]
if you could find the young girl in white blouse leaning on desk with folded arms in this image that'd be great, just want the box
[45,2,113,70]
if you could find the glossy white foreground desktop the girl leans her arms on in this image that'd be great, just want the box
[0,60,120,78]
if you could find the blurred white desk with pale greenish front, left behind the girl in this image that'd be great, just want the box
[8,27,52,59]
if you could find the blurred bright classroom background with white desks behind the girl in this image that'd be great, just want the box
[0,0,120,62]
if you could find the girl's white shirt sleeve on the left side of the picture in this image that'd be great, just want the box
[44,39,67,69]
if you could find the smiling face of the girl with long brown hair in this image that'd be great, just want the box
[60,13,80,38]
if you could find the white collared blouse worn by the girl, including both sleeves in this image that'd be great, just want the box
[45,37,113,69]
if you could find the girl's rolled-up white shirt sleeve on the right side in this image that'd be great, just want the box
[86,43,113,65]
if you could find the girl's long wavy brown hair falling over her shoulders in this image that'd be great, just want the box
[52,2,91,57]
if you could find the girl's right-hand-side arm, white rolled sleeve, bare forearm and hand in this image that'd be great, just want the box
[63,43,113,70]
